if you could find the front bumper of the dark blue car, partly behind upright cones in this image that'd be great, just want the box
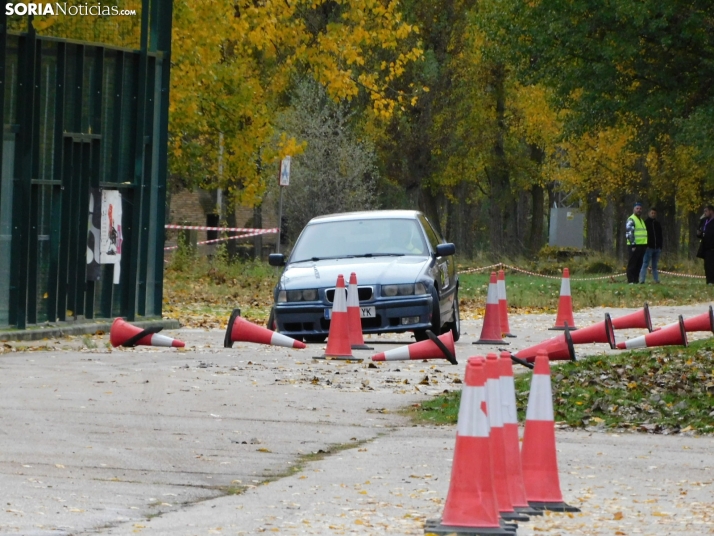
[274,295,433,337]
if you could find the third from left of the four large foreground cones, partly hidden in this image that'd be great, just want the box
[499,352,543,516]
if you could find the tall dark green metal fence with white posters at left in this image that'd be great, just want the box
[0,0,172,329]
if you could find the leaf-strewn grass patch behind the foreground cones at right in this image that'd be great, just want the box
[408,338,714,434]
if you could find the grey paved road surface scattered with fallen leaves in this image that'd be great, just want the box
[0,306,714,536]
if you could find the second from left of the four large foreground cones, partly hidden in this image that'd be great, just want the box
[484,353,529,521]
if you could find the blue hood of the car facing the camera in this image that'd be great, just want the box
[280,255,431,290]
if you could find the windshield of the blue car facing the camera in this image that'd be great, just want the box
[291,219,429,262]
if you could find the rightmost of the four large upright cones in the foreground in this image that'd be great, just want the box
[521,350,580,512]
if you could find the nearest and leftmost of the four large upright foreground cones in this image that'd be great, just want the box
[424,358,513,536]
